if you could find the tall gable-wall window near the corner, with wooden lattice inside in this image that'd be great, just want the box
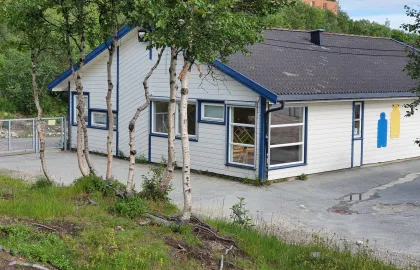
[229,107,256,167]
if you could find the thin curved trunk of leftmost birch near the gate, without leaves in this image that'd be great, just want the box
[31,50,52,182]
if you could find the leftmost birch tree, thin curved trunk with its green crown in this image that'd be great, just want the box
[6,0,53,182]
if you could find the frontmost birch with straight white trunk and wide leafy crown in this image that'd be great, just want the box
[129,0,289,223]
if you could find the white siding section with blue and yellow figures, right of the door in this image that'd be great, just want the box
[363,99,420,164]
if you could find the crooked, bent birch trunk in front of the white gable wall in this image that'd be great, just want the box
[125,47,165,196]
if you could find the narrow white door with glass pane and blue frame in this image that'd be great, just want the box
[351,101,364,168]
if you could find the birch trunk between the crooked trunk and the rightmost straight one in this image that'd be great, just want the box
[158,46,178,196]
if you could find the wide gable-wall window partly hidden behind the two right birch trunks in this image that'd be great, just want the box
[152,101,197,137]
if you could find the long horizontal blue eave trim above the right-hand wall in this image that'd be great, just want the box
[278,90,417,101]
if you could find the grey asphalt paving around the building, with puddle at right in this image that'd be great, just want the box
[0,152,420,262]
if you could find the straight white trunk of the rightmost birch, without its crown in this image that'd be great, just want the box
[180,61,191,224]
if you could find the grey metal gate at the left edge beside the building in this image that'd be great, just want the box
[0,117,66,154]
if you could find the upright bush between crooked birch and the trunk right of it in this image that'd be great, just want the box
[140,162,172,201]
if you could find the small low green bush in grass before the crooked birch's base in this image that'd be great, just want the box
[109,196,146,219]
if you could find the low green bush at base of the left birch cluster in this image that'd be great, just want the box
[74,175,125,197]
